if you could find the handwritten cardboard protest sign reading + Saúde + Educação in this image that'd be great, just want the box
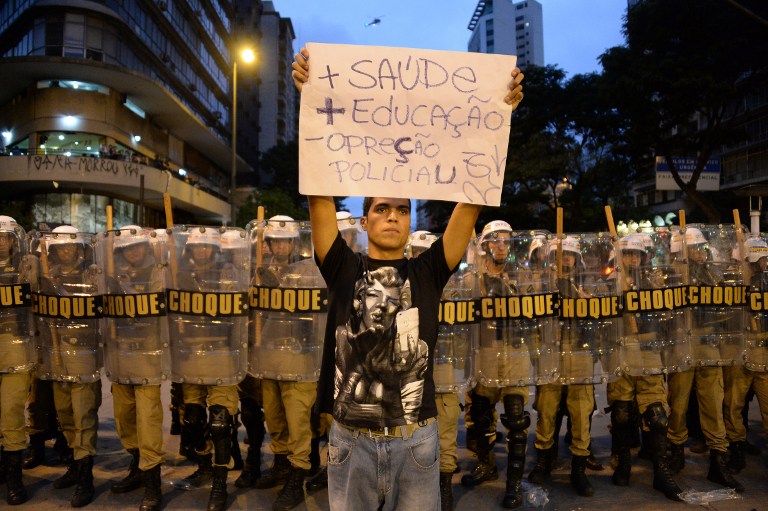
[299,43,517,206]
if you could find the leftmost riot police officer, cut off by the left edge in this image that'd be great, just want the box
[0,215,35,505]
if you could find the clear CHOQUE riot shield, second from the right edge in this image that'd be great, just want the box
[683,224,747,366]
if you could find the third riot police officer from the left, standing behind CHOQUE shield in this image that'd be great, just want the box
[100,225,169,511]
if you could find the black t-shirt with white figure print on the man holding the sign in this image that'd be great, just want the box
[316,235,453,428]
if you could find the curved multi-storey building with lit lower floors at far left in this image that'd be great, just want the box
[0,0,251,231]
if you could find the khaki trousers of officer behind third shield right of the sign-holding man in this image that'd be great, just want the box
[533,383,595,456]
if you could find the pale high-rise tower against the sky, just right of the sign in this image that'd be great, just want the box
[467,0,544,69]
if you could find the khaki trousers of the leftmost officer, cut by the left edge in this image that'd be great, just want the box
[0,373,32,451]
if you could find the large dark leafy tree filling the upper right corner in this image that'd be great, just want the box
[601,0,768,223]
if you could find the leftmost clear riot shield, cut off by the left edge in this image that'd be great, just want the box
[0,216,35,373]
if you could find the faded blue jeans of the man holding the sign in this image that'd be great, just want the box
[328,421,440,511]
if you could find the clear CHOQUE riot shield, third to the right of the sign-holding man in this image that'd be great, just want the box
[549,233,621,385]
